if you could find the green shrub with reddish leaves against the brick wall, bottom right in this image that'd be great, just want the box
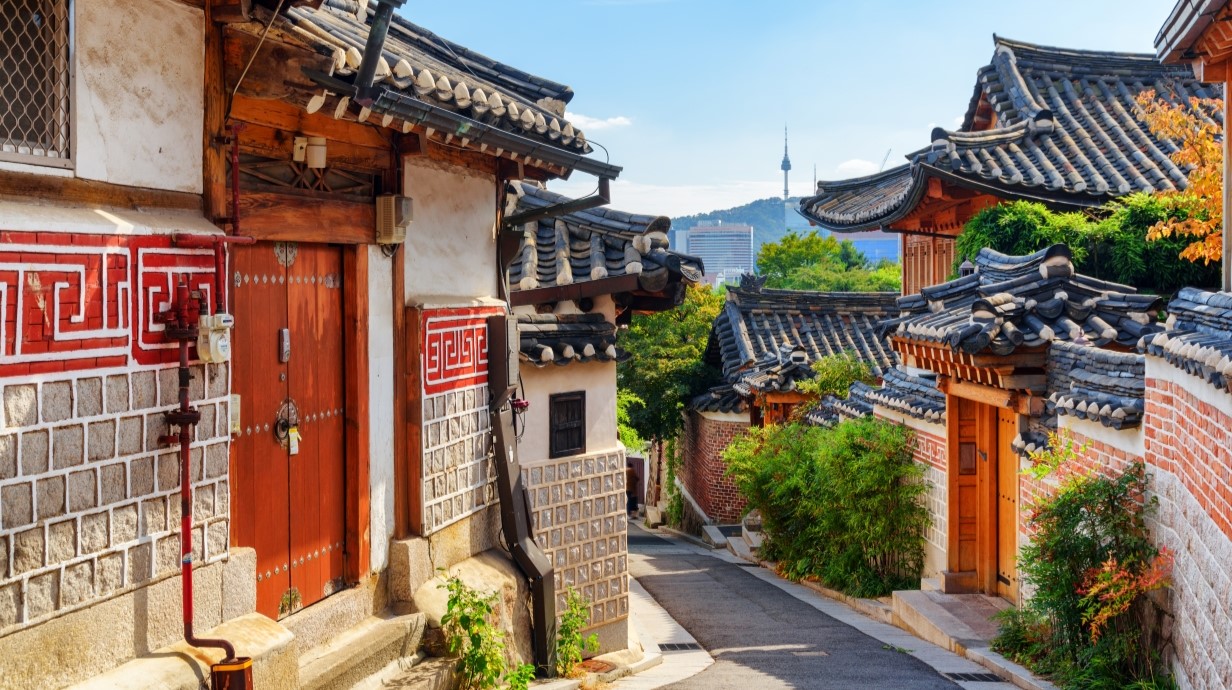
[993,437,1170,689]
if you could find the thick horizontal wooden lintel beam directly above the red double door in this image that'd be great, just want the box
[232,190,376,244]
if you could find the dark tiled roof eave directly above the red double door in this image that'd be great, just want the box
[277,0,618,170]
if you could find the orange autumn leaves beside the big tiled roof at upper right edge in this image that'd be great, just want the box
[1137,90,1223,264]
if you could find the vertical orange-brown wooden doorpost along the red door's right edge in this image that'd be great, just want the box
[342,245,372,582]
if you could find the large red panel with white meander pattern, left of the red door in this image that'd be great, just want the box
[0,232,214,377]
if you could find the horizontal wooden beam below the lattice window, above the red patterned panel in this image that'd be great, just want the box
[0,170,201,212]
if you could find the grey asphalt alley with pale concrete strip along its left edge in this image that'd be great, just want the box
[615,524,1014,690]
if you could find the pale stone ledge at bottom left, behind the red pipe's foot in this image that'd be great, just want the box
[73,614,297,690]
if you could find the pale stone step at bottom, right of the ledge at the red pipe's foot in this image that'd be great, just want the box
[299,612,428,690]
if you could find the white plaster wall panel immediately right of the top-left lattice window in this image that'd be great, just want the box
[73,0,205,193]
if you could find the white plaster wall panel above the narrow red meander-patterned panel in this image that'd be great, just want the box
[404,160,496,307]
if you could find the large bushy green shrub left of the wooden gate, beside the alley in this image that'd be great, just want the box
[723,418,929,596]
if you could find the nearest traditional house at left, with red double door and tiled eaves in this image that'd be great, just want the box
[0,0,635,686]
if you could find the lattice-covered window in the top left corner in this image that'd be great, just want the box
[0,0,71,168]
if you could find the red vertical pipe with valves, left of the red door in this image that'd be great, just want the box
[160,278,235,662]
